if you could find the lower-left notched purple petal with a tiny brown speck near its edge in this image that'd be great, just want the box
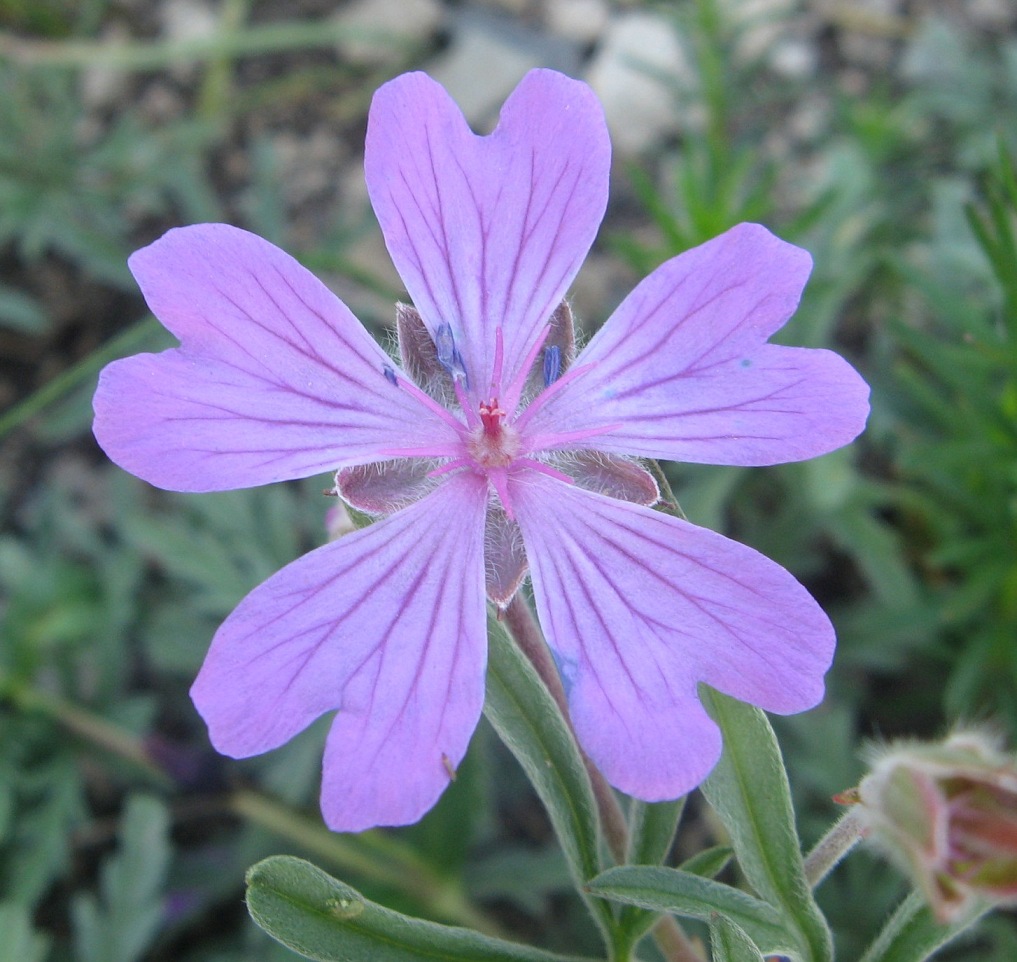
[191,474,487,831]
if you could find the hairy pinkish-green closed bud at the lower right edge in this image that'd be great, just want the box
[857,731,1017,922]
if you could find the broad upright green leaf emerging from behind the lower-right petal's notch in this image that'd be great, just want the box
[700,685,833,962]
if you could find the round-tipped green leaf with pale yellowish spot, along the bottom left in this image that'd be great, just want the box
[247,855,593,962]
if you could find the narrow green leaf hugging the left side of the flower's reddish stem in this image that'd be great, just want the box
[484,618,605,907]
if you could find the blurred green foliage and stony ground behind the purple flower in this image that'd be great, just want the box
[0,0,1017,962]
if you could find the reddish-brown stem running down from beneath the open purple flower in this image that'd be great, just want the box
[503,594,703,962]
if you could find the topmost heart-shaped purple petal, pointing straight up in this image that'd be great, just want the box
[364,70,610,400]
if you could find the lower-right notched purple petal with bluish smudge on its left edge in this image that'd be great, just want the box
[512,472,834,801]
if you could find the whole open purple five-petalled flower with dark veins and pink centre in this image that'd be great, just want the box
[95,70,868,830]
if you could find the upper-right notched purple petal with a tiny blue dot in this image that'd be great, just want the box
[524,224,869,465]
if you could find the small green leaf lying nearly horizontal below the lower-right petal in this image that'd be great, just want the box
[587,865,797,954]
